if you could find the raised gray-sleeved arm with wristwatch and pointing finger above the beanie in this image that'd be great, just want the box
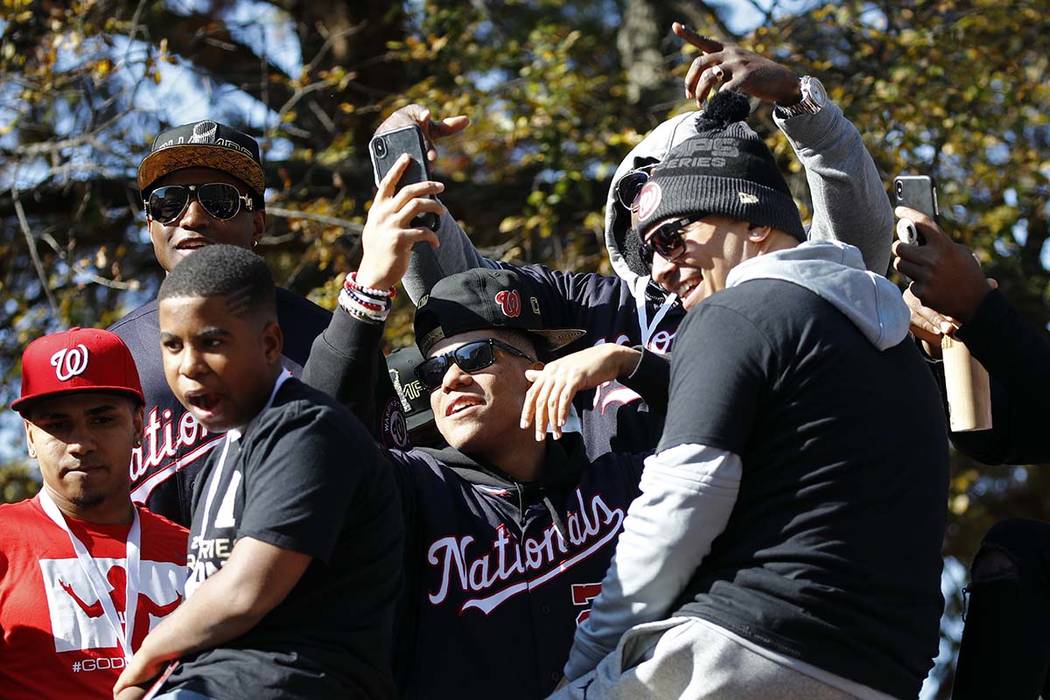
[673,22,894,275]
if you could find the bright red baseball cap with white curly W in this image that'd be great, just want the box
[11,328,146,412]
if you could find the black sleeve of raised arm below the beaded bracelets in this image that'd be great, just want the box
[302,307,395,440]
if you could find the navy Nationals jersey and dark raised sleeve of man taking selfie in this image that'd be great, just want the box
[303,309,643,700]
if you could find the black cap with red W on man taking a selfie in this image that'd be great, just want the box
[415,268,585,357]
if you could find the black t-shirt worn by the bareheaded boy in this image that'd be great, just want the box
[165,378,403,700]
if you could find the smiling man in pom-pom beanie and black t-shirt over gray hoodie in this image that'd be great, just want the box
[555,92,948,700]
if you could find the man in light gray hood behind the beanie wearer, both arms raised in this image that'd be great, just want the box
[388,35,893,459]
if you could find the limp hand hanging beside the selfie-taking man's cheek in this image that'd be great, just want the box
[521,343,642,441]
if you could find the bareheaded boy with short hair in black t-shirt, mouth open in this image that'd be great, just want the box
[114,246,403,700]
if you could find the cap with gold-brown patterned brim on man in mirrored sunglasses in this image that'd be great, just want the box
[139,121,266,197]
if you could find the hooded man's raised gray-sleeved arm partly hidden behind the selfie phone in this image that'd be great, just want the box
[376,104,498,303]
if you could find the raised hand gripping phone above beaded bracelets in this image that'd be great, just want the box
[357,154,445,290]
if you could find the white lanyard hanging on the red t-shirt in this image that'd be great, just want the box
[40,488,142,662]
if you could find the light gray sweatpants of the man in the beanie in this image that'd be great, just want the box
[550,617,889,700]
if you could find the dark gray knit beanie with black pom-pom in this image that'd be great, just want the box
[637,91,805,241]
